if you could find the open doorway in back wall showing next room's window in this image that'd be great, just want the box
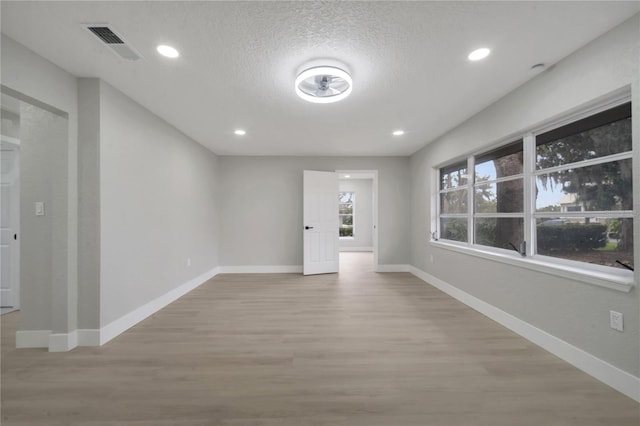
[337,170,378,272]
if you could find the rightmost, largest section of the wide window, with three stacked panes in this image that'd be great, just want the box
[533,103,633,267]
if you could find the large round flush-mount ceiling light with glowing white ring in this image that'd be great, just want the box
[295,66,353,104]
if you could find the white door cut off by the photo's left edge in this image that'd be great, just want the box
[0,143,20,313]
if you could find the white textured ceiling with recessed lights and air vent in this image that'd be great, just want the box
[0,1,640,155]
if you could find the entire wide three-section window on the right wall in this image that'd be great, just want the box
[435,102,633,268]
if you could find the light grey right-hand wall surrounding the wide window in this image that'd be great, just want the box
[410,15,640,377]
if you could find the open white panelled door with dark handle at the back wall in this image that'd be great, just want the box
[302,170,339,275]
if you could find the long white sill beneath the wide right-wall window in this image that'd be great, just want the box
[431,240,634,293]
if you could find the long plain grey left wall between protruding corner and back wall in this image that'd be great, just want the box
[99,82,219,327]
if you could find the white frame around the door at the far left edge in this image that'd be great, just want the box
[0,134,20,314]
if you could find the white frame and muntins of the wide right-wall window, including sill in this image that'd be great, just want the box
[430,89,639,292]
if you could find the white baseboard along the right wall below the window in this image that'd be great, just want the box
[410,266,640,402]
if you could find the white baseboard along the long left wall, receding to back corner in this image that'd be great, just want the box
[100,268,220,345]
